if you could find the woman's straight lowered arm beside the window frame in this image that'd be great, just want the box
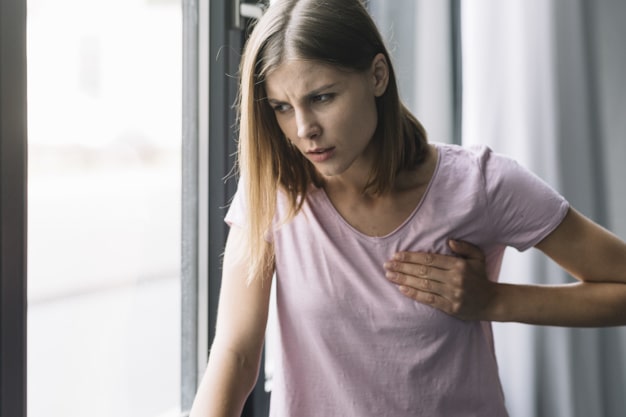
[189,226,273,417]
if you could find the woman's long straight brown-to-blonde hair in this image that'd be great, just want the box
[238,0,426,279]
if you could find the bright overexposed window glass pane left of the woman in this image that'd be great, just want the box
[28,0,182,417]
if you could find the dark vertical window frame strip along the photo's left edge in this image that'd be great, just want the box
[0,0,27,417]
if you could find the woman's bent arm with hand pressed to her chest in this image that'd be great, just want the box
[385,209,626,327]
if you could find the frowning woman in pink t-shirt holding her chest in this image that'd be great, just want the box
[191,0,626,417]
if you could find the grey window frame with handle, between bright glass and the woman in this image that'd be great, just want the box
[181,0,269,417]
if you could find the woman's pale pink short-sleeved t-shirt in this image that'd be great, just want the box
[226,144,569,417]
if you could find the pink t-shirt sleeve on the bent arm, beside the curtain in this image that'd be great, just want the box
[481,148,569,251]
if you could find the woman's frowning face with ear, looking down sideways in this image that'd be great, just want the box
[265,54,388,176]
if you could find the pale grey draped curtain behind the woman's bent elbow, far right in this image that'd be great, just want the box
[461,0,626,417]
